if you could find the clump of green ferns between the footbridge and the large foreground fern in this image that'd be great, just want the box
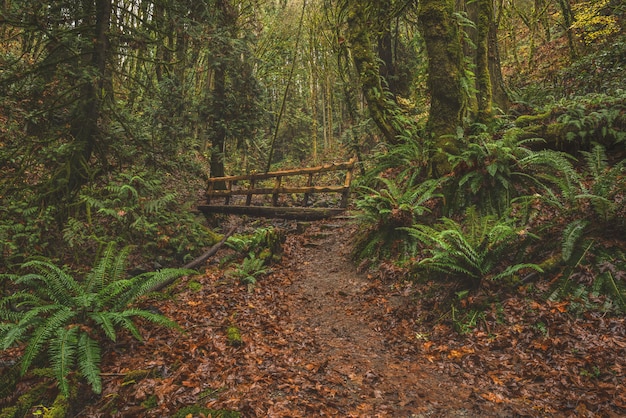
[63,171,214,262]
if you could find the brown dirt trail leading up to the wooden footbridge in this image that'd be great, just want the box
[283,221,494,417]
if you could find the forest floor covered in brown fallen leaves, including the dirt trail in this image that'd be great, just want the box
[2,219,626,417]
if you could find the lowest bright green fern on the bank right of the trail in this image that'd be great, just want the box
[407,207,541,287]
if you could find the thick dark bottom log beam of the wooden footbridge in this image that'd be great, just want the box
[198,205,345,221]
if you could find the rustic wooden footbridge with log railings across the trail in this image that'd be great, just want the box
[198,158,356,220]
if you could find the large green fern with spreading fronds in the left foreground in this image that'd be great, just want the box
[0,244,191,395]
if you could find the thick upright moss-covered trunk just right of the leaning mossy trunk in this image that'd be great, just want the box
[418,0,466,175]
